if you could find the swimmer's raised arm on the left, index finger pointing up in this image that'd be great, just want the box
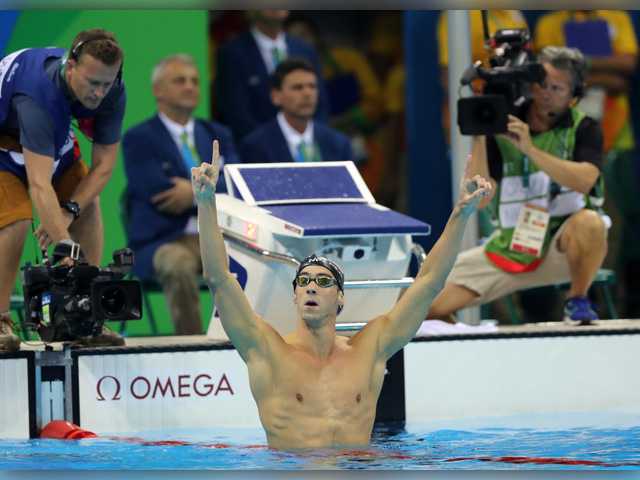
[191,140,270,362]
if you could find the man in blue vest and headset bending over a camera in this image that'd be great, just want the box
[0,29,126,351]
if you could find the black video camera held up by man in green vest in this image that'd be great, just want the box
[458,29,546,135]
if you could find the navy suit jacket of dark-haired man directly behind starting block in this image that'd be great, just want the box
[240,118,353,163]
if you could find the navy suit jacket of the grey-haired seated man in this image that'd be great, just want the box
[122,115,239,280]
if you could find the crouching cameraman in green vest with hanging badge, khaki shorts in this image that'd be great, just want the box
[428,47,610,324]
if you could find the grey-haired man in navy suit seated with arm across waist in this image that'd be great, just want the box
[122,54,238,335]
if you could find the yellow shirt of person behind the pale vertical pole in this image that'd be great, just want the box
[438,10,529,67]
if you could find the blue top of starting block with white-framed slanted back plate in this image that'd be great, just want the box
[224,162,431,237]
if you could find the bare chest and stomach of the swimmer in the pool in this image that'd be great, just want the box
[248,322,386,448]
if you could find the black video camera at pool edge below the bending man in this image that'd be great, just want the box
[22,248,142,342]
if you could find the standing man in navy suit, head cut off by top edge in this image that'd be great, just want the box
[214,10,329,142]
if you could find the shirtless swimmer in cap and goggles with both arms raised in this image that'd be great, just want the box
[192,143,491,448]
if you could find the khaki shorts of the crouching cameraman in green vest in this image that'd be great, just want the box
[447,226,571,306]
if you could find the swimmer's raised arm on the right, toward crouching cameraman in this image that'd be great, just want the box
[359,158,492,360]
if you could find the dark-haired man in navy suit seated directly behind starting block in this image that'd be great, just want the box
[240,58,353,163]
